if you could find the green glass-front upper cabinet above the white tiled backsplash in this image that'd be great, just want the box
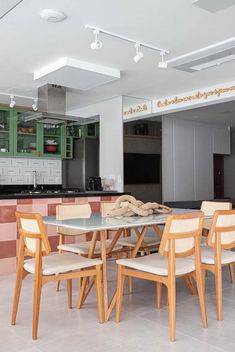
[0,107,99,159]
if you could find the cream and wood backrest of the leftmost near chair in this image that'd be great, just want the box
[16,212,51,256]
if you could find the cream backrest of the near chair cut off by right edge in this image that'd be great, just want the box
[208,210,235,249]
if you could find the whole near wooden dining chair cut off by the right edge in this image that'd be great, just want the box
[201,210,235,320]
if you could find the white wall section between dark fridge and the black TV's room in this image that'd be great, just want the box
[66,96,123,192]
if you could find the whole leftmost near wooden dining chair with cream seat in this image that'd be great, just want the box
[11,213,104,340]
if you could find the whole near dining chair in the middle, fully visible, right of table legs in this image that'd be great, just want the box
[116,212,207,341]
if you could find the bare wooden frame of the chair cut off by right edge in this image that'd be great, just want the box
[202,210,235,320]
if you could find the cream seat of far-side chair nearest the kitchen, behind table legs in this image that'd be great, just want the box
[57,240,122,255]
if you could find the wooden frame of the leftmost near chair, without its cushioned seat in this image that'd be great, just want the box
[11,212,104,340]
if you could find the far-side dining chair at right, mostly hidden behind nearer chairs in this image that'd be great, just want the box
[201,201,235,284]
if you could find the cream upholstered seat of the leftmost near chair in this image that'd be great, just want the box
[24,253,102,275]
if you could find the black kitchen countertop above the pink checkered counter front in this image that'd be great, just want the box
[0,191,128,199]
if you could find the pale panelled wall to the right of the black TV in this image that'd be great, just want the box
[162,117,230,201]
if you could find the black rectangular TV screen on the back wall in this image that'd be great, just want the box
[124,153,160,184]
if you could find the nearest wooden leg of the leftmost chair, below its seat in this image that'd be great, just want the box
[32,275,42,340]
